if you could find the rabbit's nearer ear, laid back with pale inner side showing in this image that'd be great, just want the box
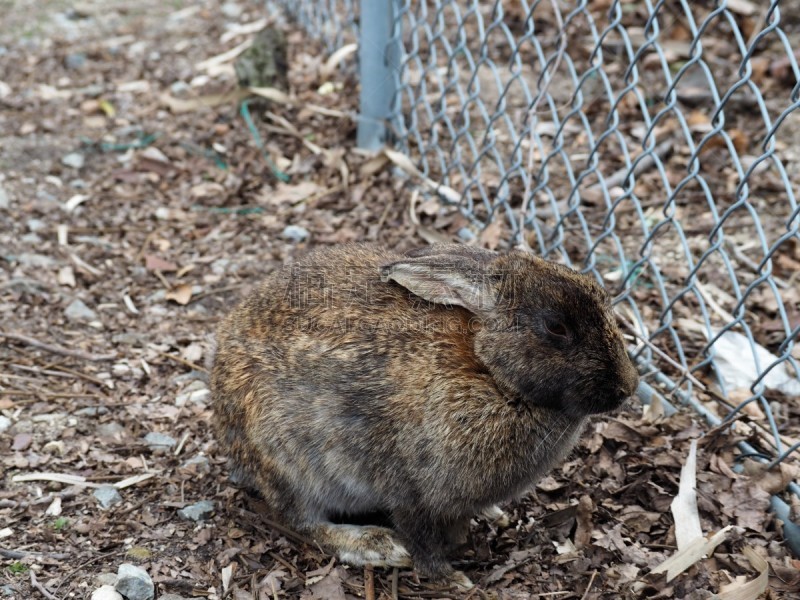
[381,255,497,314]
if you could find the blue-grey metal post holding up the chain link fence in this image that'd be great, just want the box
[357,0,400,150]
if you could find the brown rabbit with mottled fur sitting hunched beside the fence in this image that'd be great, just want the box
[211,244,638,586]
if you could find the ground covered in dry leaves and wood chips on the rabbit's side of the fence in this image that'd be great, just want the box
[0,0,800,600]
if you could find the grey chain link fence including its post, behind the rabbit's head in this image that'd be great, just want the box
[277,0,800,547]
